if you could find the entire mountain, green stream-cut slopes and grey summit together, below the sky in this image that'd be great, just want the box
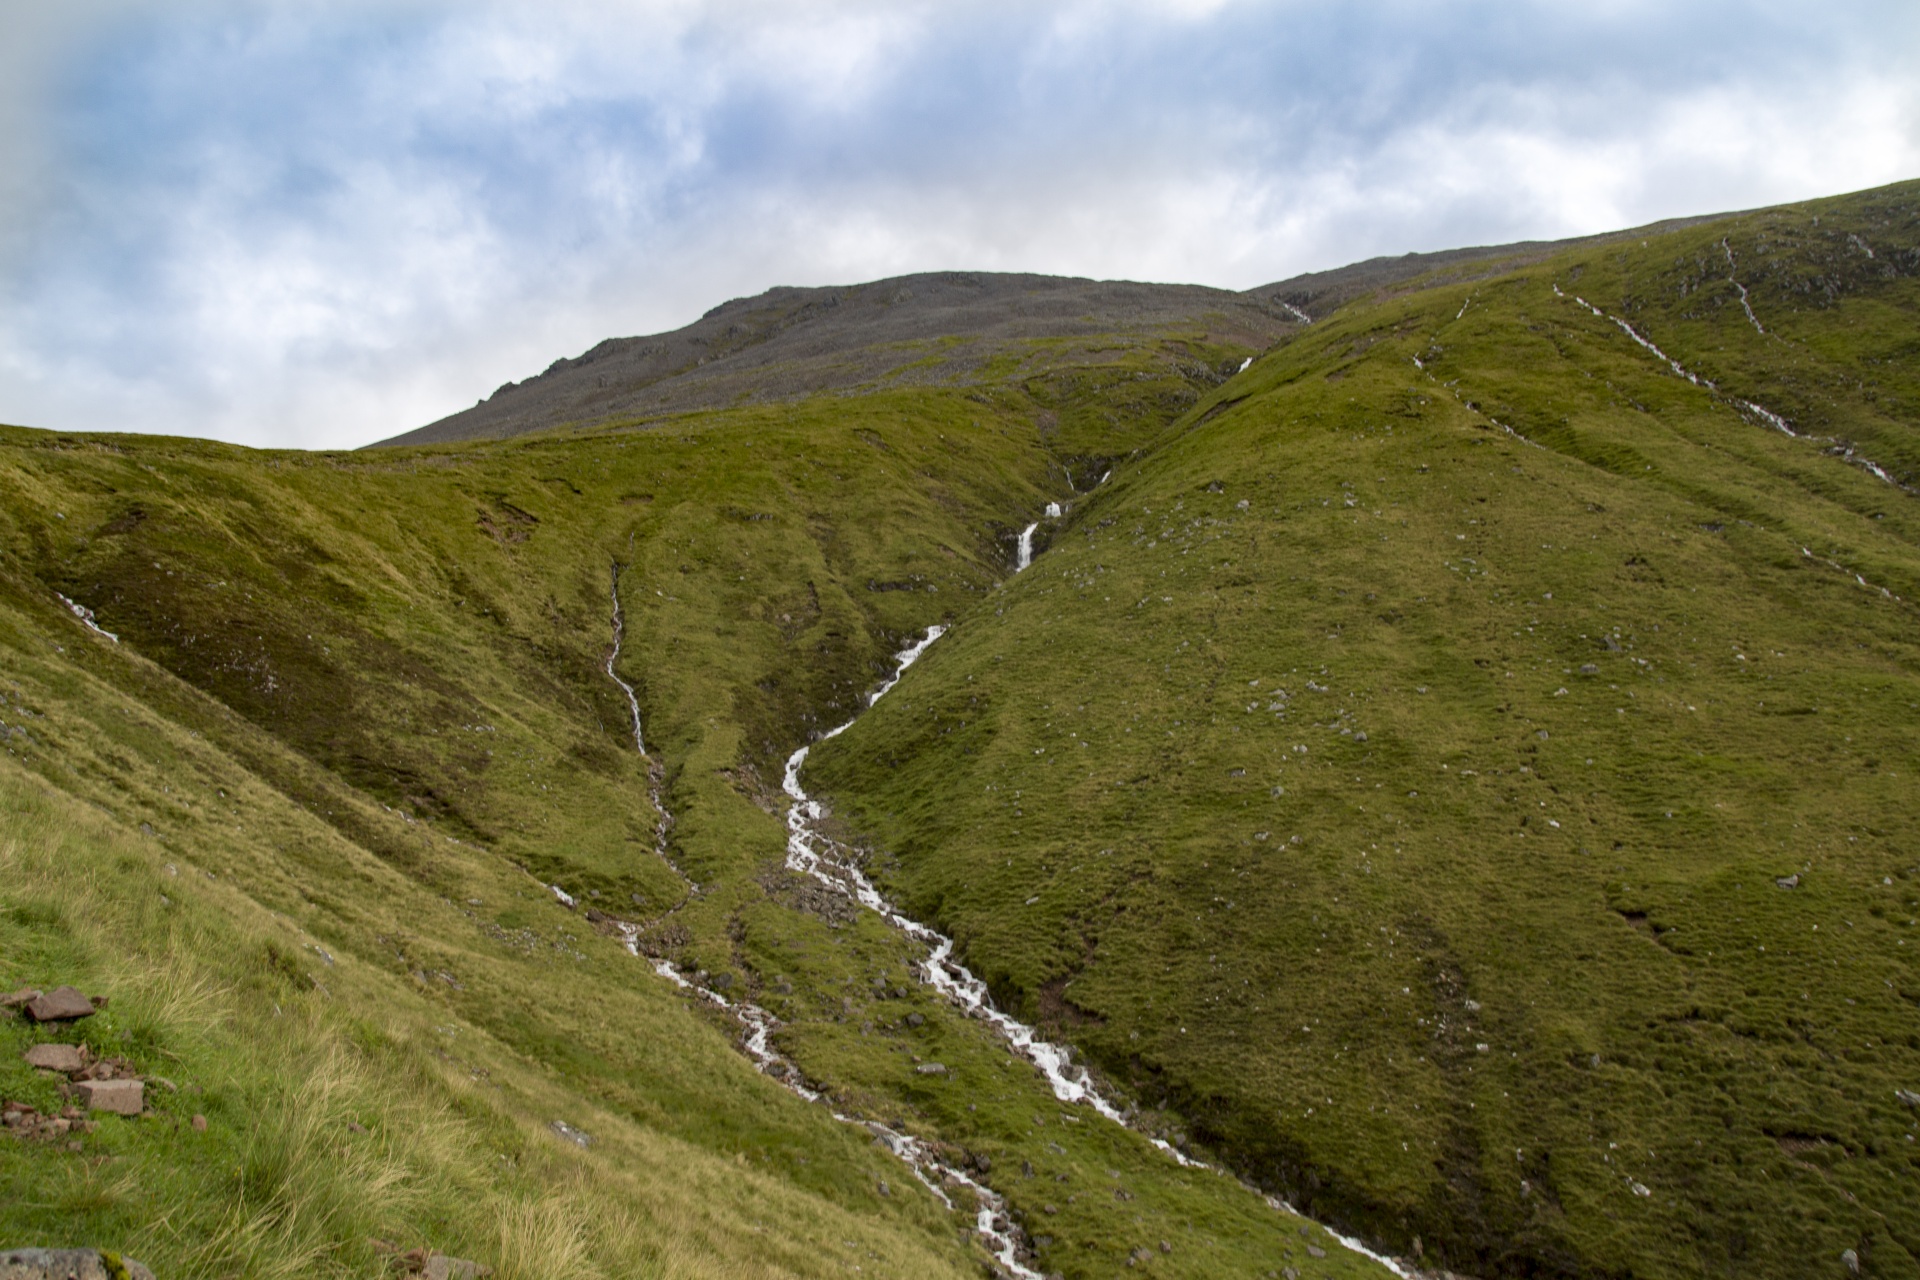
[0,172,1920,1276]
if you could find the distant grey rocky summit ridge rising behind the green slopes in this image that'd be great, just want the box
[380,208,1699,445]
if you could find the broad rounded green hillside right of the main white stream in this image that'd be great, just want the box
[812,184,1920,1278]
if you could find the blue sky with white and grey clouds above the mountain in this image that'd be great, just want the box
[0,0,1920,449]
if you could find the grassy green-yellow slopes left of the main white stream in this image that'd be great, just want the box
[0,334,1377,1276]
